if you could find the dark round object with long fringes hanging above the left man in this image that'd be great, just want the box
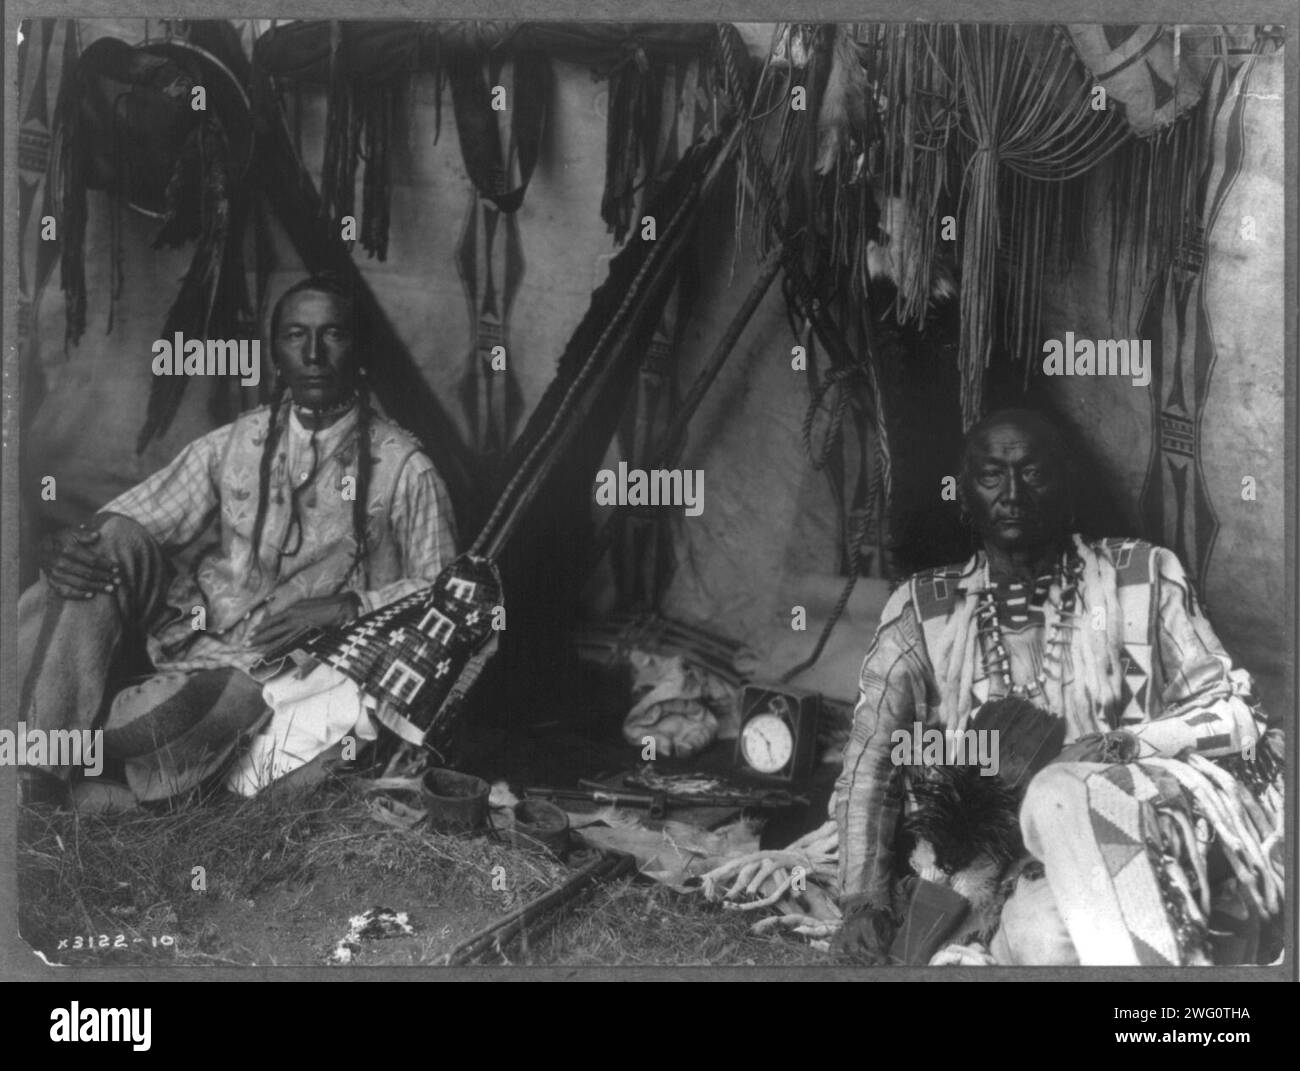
[51,22,252,451]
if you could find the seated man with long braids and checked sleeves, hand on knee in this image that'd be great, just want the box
[20,276,455,806]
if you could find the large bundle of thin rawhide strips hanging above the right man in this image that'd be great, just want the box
[885,25,1127,428]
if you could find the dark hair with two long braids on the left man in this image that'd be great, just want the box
[252,273,372,585]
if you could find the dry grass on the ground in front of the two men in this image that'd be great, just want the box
[18,780,828,966]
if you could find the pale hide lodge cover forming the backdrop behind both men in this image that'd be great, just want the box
[18,19,1290,698]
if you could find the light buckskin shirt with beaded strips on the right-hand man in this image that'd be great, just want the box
[835,537,1264,906]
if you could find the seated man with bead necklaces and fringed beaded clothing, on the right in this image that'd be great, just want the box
[832,409,1281,966]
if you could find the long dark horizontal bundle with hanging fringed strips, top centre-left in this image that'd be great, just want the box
[255,21,714,230]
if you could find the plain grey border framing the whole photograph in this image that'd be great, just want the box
[0,0,1300,983]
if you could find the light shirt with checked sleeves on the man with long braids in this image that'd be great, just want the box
[103,407,455,669]
